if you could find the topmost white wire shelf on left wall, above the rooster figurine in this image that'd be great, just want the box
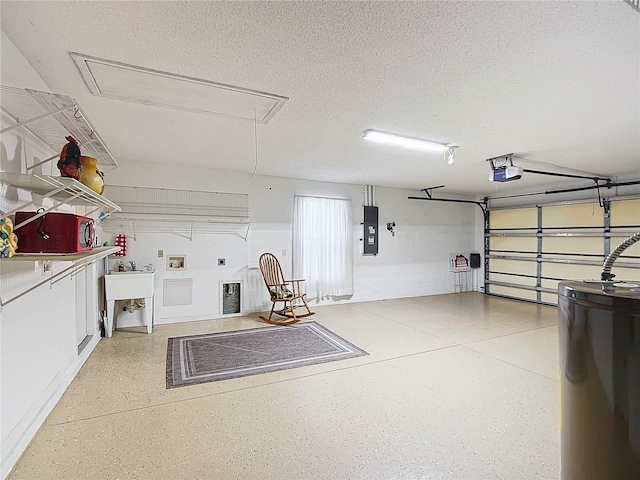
[0,85,118,171]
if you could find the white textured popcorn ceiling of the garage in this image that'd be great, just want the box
[0,0,640,195]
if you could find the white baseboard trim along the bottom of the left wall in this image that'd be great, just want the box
[0,335,101,480]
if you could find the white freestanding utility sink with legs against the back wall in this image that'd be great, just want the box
[104,270,155,337]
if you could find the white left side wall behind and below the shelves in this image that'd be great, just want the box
[0,33,99,478]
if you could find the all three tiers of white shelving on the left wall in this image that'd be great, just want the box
[0,85,120,308]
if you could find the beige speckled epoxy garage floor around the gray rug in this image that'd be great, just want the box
[9,293,559,480]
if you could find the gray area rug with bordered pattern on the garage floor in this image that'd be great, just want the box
[167,322,368,388]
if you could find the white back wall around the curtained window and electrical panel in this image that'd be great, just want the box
[101,162,479,326]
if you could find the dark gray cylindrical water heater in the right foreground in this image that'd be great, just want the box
[558,281,640,480]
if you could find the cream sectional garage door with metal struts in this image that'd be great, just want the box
[485,199,640,305]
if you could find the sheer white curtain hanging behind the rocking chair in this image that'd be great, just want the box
[293,196,353,299]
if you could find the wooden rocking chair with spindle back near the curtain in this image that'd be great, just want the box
[258,253,315,325]
